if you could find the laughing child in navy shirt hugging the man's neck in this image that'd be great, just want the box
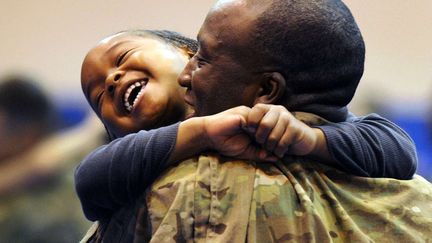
[75,30,417,238]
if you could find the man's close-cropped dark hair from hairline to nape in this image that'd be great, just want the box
[246,0,365,119]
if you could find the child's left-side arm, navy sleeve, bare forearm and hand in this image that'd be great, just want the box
[75,107,266,220]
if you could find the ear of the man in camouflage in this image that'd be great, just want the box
[254,72,286,104]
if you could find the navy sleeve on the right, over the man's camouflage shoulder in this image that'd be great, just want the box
[318,114,417,179]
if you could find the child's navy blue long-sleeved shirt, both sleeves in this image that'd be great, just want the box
[75,114,417,221]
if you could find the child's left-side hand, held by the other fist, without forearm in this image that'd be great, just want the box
[203,106,276,160]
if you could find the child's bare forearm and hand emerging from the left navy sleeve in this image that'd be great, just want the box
[168,106,274,163]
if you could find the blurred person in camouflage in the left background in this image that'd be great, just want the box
[0,75,104,243]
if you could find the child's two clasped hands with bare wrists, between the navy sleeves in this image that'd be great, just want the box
[170,104,330,164]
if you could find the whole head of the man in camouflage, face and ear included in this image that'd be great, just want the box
[179,0,365,121]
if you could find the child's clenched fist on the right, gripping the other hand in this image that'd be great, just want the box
[247,104,322,157]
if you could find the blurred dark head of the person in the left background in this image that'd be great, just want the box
[0,76,59,161]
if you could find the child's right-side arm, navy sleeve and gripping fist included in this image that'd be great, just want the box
[247,104,417,179]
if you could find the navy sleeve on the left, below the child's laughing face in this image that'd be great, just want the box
[75,123,179,221]
